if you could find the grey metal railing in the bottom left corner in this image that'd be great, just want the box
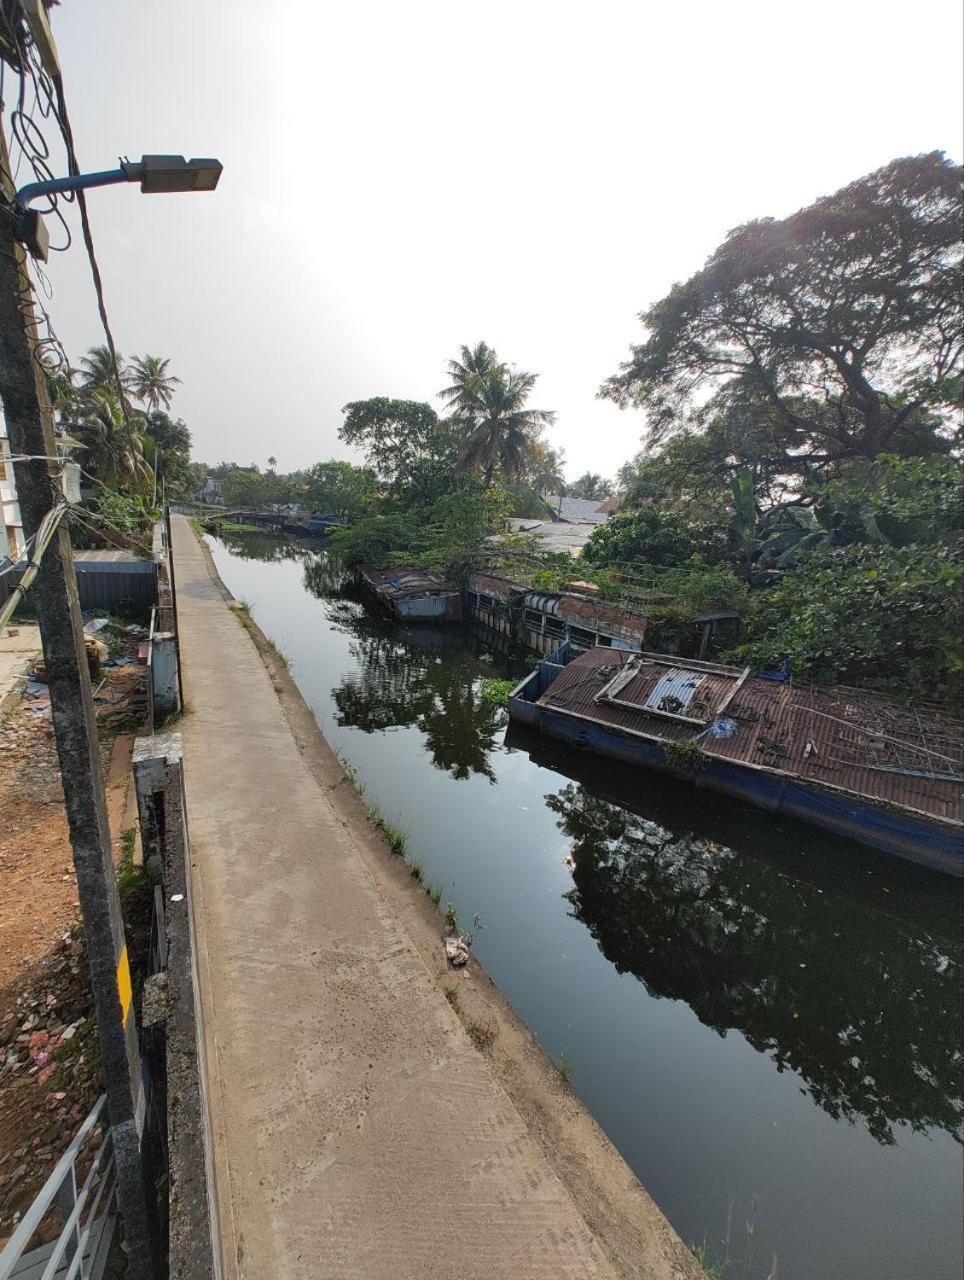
[0,1093,118,1280]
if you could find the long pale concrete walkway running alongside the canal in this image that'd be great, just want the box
[174,517,624,1280]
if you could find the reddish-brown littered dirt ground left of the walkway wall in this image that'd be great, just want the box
[0,628,146,1245]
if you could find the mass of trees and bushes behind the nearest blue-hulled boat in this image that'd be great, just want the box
[582,152,964,707]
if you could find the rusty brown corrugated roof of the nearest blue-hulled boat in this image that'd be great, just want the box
[539,648,964,823]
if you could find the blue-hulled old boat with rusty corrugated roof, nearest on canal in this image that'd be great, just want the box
[508,641,964,876]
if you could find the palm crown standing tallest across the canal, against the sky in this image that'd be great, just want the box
[439,342,556,485]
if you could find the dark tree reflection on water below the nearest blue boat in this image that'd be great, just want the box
[545,783,964,1143]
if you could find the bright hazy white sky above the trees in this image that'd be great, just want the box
[35,0,964,477]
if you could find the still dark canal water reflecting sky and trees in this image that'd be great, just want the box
[204,535,964,1280]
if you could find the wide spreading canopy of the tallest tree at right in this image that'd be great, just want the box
[602,152,964,461]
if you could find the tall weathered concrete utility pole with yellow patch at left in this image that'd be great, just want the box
[0,129,157,1280]
